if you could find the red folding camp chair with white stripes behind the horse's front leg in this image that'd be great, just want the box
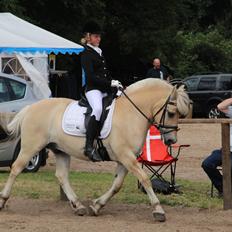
[137,126,190,194]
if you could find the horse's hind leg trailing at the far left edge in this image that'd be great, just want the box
[0,149,37,210]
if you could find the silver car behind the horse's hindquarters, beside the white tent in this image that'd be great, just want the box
[0,73,47,172]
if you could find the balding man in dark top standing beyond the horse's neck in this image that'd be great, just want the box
[146,58,170,81]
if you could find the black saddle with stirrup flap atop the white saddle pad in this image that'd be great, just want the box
[78,93,117,161]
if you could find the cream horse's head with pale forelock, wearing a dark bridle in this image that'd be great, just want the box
[154,86,190,145]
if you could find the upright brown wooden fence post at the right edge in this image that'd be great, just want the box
[221,123,232,210]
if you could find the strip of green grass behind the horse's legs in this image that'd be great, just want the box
[0,170,223,209]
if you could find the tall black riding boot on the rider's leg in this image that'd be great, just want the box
[85,116,103,162]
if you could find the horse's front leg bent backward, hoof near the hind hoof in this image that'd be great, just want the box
[90,163,128,216]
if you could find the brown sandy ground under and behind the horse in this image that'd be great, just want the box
[0,124,232,232]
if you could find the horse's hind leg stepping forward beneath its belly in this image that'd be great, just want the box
[55,153,87,216]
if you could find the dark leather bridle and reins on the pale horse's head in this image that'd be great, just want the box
[120,88,179,134]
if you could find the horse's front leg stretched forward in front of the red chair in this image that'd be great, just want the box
[120,151,166,222]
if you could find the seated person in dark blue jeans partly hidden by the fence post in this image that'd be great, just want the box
[201,98,232,196]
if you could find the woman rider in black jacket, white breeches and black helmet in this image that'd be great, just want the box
[81,21,122,162]
